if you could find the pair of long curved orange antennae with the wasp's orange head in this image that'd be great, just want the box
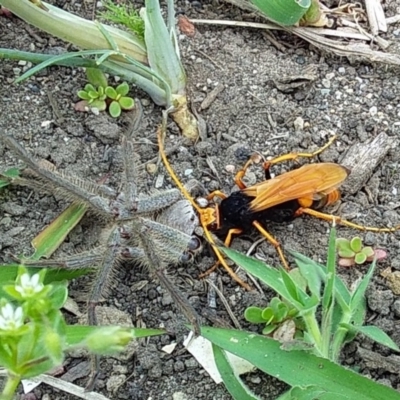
[157,112,251,290]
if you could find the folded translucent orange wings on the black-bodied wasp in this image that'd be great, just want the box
[242,163,349,212]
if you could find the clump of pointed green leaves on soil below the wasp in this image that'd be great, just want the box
[202,227,400,400]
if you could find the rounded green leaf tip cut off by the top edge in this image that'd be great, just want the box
[251,0,311,26]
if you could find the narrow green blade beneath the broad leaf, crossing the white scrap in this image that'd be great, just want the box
[212,344,260,400]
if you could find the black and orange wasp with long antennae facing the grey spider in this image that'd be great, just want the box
[158,115,400,289]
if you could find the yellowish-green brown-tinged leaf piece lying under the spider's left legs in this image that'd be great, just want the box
[28,202,87,260]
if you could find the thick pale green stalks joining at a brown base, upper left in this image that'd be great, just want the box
[0,0,198,139]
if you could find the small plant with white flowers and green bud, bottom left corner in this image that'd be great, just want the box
[0,265,164,400]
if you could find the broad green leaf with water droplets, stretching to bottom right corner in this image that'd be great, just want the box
[201,327,400,400]
